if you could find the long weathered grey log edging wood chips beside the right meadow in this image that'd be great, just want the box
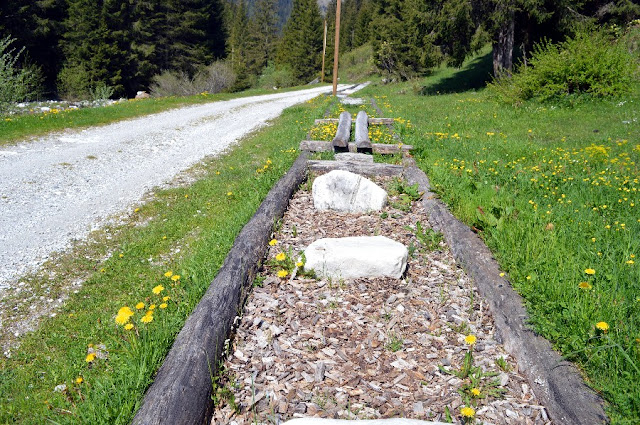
[404,159,609,425]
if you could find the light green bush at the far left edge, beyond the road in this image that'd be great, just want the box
[0,36,42,112]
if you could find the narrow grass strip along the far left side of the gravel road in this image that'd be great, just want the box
[0,86,328,147]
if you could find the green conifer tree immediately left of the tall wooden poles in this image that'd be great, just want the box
[276,0,323,83]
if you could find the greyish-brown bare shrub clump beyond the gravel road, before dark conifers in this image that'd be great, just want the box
[150,61,236,97]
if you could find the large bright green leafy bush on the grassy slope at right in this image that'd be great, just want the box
[489,31,637,104]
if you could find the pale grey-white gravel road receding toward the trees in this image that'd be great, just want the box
[0,87,344,291]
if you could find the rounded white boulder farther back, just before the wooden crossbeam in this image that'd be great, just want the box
[312,170,387,213]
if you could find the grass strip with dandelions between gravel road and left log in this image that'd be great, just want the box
[0,93,338,424]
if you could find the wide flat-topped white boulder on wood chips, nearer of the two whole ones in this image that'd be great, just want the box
[304,236,409,279]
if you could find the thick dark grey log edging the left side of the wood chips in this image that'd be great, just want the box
[132,152,307,425]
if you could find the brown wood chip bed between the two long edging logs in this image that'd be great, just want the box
[211,179,552,425]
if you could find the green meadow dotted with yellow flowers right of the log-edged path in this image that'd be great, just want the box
[360,59,640,424]
